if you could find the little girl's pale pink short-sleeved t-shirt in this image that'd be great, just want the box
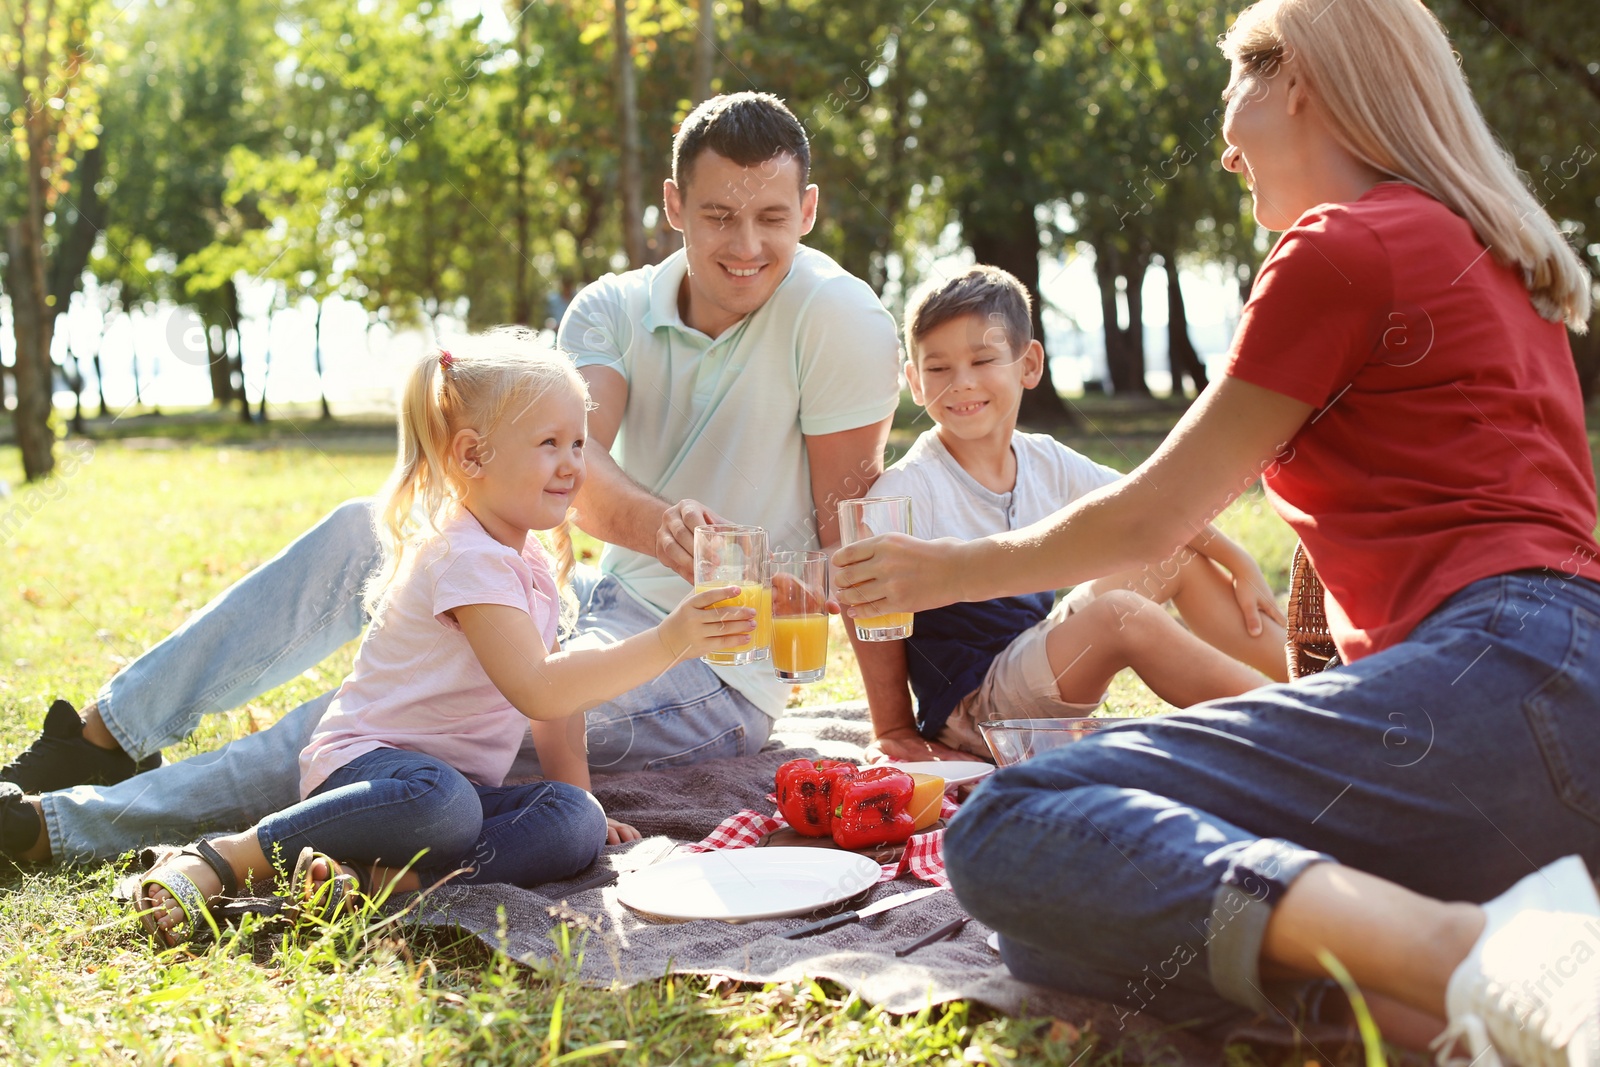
[301,512,560,797]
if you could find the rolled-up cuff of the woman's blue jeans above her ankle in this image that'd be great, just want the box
[1206,838,1338,1014]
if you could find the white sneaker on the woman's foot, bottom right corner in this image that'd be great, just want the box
[1434,856,1600,1067]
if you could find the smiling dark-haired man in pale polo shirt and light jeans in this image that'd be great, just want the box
[0,93,898,862]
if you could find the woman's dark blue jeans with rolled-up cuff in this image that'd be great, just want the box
[944,571,1600,1025]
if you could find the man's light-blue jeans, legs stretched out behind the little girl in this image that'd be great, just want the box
[42,501,771,864]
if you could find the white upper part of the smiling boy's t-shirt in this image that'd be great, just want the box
[867,430,1122,541]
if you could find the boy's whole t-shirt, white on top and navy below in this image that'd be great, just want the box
[867,430,1122,737]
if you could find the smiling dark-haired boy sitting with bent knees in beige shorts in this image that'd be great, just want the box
[856,267,1286,760]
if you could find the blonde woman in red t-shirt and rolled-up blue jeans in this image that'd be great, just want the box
[835,0,1600,1064]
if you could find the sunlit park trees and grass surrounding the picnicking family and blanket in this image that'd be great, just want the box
[0,0,1600,1067]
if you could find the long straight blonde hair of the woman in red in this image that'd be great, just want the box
[1221,0,1592,333]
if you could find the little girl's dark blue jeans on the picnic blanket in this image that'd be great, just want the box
[256,749,606,886]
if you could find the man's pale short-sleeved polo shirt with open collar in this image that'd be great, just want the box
[557,246,899,717]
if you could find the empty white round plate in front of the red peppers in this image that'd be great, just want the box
[618,848,883,923]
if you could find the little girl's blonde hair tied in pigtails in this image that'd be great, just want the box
[363,326,589,621]
